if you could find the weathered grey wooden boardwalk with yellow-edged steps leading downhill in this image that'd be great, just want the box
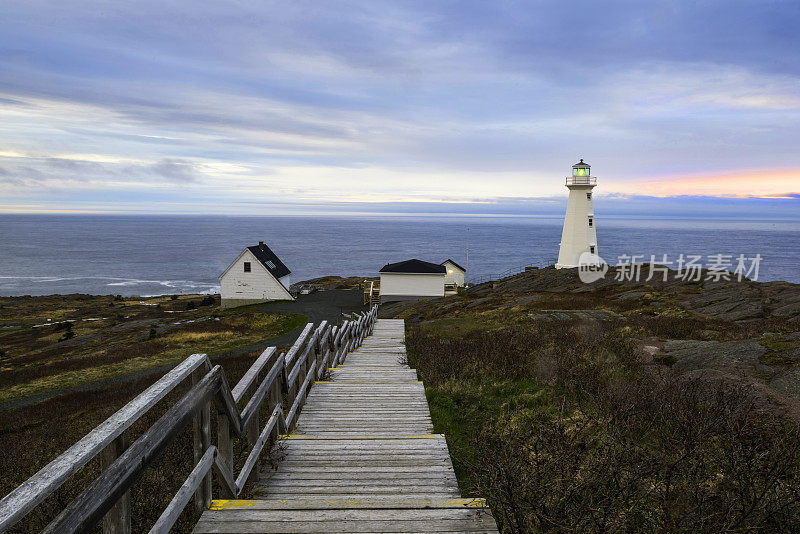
[195,319,497,533]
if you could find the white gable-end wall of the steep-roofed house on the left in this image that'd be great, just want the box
[219,250,292,300]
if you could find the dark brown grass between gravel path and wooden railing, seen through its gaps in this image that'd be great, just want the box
[0,351,266,532]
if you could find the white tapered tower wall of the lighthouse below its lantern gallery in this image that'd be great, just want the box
[556,185,600,268]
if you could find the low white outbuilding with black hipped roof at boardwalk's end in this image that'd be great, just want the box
[379,259,447,303]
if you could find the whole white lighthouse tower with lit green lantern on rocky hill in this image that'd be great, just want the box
[556,160,598,269]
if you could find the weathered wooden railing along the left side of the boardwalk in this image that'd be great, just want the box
[0,307,377,534]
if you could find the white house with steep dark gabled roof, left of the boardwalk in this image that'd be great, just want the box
[219,241,294,308]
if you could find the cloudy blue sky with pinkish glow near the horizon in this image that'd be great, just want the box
[0,0,800,218]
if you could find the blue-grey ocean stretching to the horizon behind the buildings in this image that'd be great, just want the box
[0,214,800,296]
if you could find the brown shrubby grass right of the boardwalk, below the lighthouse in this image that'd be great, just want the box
[402,274,800,533]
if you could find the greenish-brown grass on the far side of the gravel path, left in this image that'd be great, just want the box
[0,297,307,402]
